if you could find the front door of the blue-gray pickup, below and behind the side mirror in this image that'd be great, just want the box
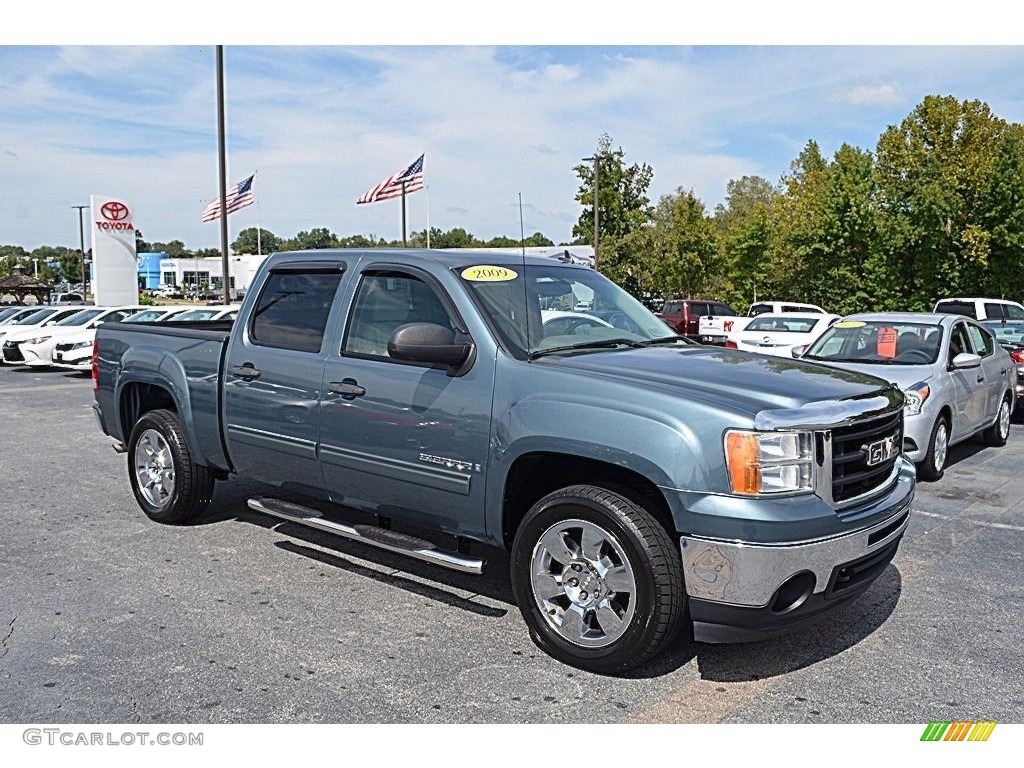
[319,264,495,534]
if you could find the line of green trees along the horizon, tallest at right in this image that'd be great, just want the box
[0,95,1024,314]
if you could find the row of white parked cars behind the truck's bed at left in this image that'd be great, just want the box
[0,305,239,371]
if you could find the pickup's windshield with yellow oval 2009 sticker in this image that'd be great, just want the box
[456,264,688,357]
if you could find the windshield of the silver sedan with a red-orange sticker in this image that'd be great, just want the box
[803,319,942,366]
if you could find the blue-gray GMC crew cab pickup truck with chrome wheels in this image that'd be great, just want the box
[93,250,915,673]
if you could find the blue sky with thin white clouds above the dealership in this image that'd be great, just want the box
[0,3,1024,249]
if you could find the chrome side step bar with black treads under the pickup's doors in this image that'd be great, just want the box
[248,497,484,575]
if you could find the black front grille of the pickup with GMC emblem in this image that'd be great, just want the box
[831,409,903,502]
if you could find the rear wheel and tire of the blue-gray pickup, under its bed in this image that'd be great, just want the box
[128,409,214,523]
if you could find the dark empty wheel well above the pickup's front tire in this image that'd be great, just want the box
[502,454,677,549]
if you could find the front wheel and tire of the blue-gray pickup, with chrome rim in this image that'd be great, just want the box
[511,485,686,674]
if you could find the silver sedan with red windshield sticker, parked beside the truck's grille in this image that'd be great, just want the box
[803,312,1017,480]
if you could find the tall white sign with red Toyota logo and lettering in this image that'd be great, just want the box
[90,195,138,306]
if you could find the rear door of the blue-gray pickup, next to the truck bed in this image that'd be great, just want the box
[223,259,347,493]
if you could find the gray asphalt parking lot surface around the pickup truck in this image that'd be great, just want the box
[0,367,1024,724]
